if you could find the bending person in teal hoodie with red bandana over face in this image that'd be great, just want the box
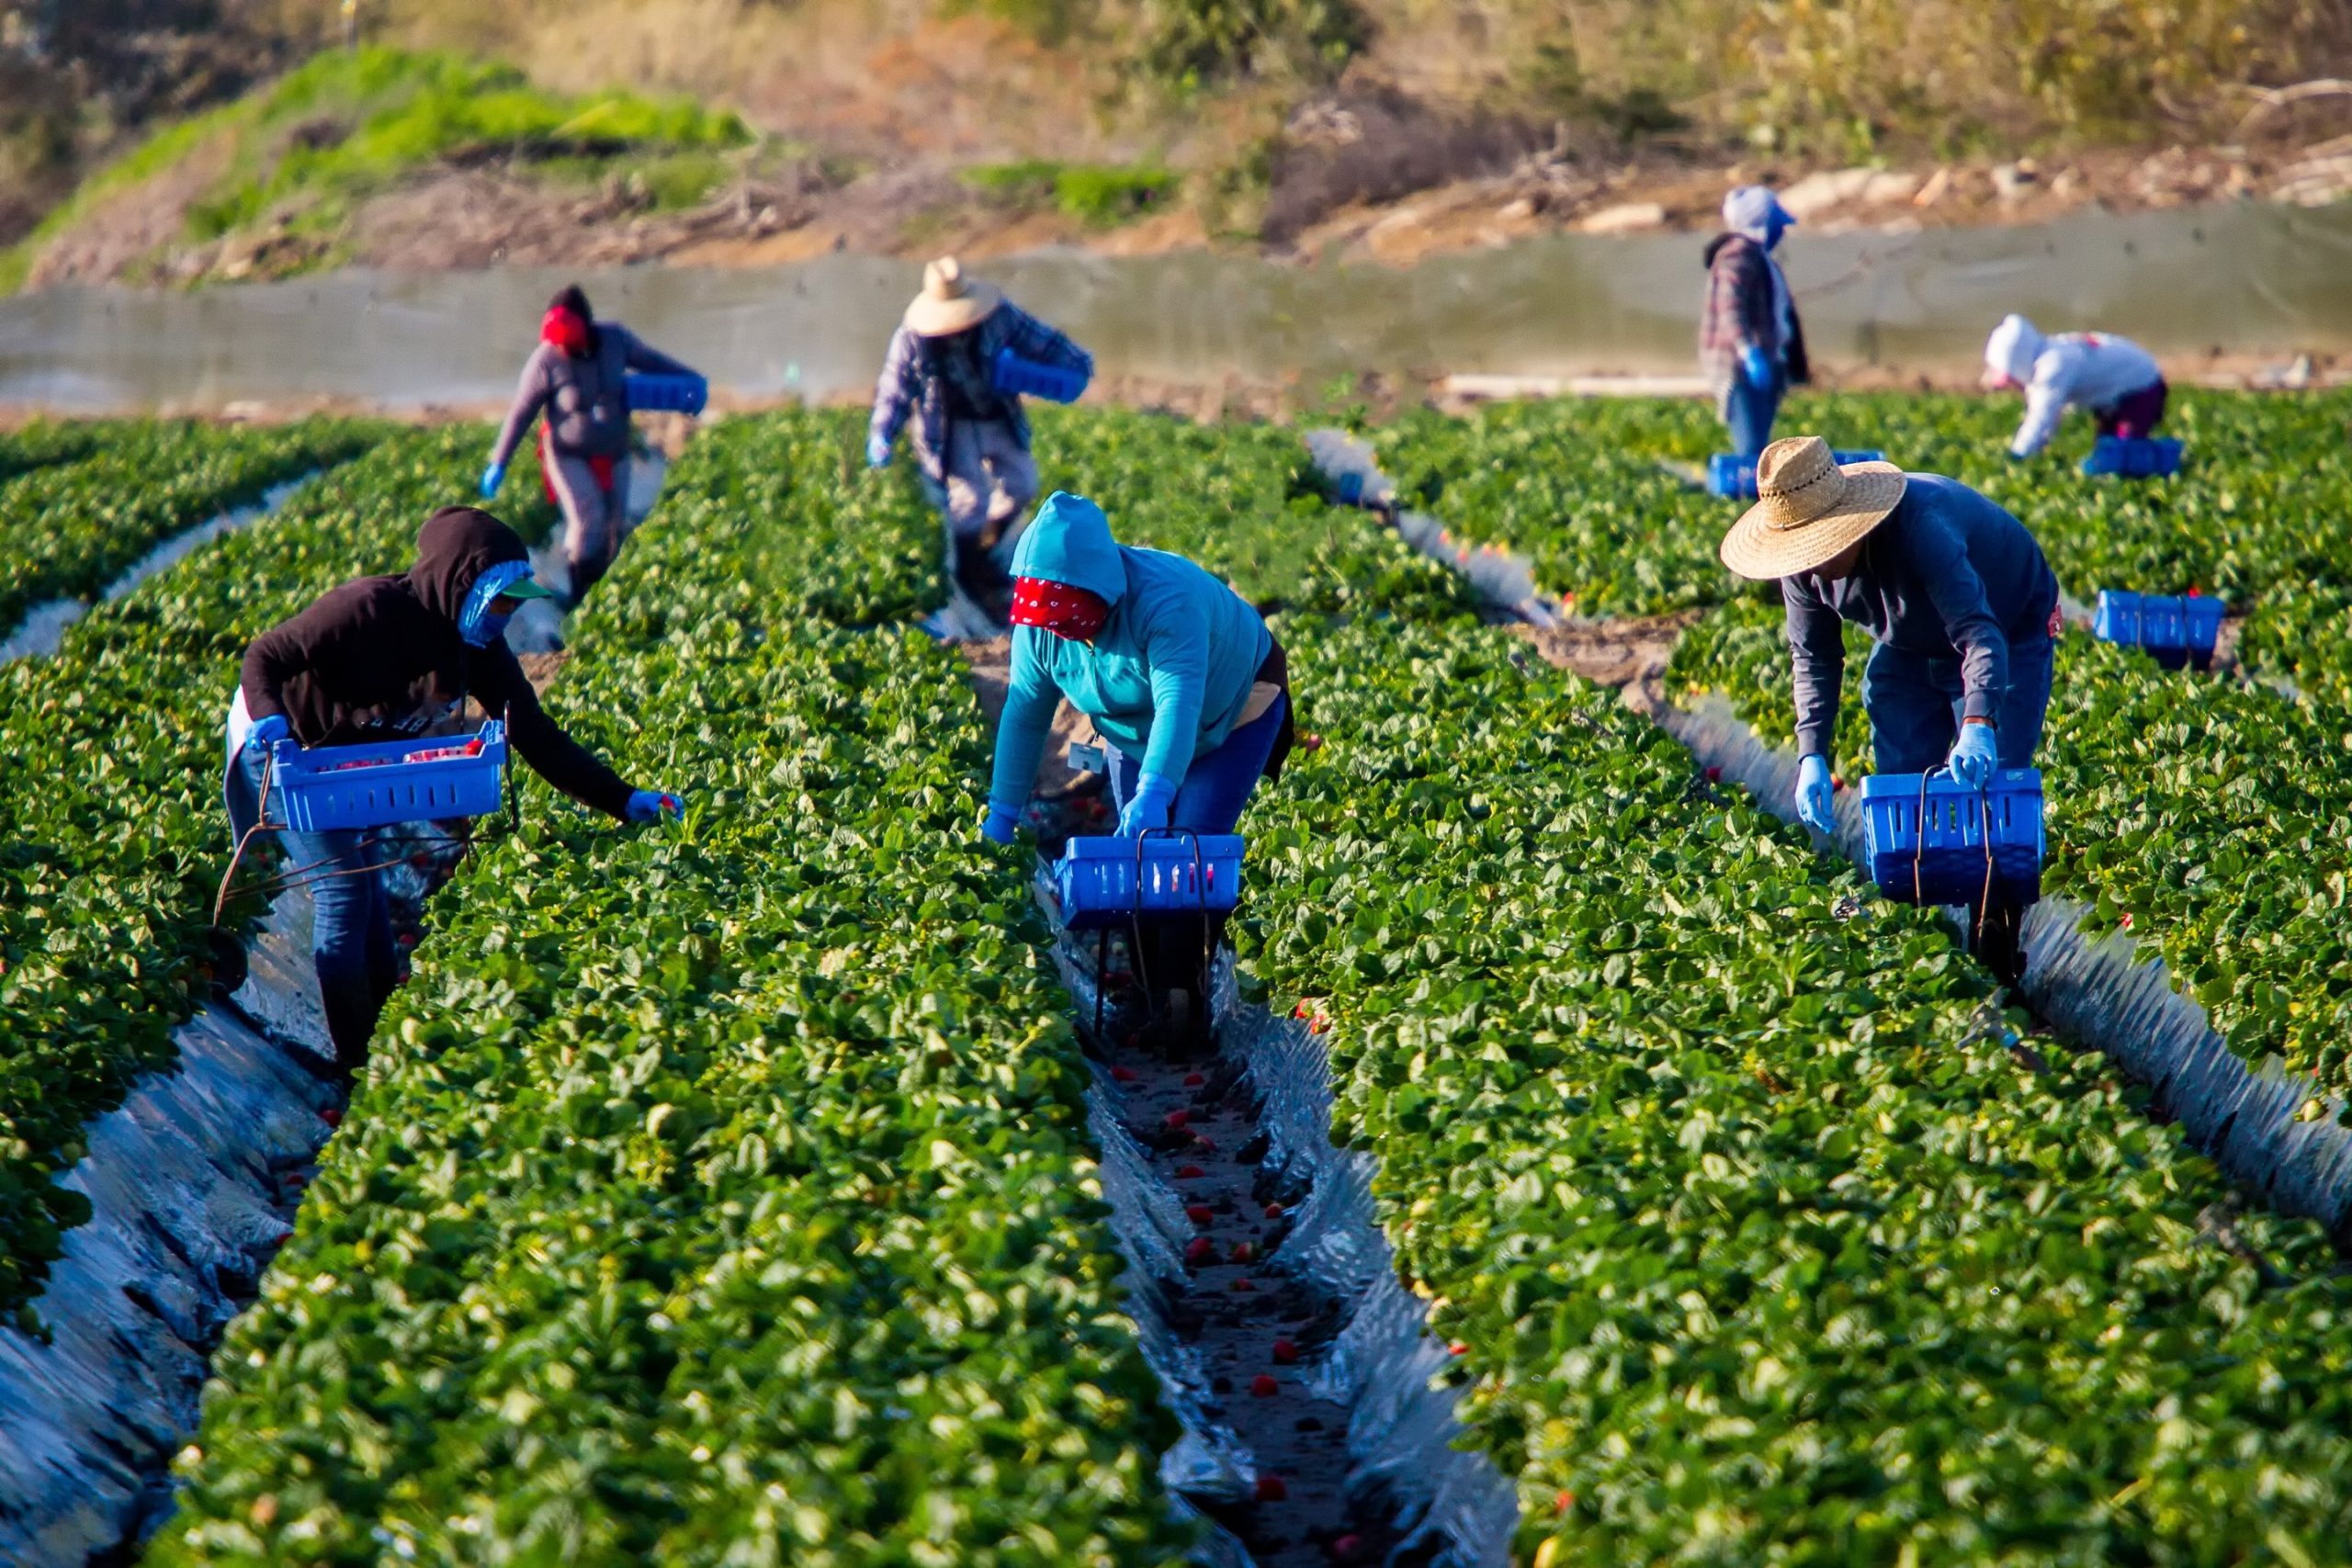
[983,491,1298,844]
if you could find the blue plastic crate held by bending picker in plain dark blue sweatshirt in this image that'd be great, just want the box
[1863,769,2044,905]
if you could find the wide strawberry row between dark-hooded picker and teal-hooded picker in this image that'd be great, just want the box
[151,416,1185,1568]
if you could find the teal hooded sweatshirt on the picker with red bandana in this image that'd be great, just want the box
[988,491,1275,813]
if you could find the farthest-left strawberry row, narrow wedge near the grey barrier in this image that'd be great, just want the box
[0,419,383,630]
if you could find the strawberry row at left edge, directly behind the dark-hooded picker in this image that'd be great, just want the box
[0,428,480,1309]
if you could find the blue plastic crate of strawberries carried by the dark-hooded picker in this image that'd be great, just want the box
[270,719,505,832]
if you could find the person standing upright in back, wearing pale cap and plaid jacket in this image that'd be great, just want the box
[1698,186,1814,463]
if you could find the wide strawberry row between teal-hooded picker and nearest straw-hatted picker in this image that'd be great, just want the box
[1239,618,2352,1568]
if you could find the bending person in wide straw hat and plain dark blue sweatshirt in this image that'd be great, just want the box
[1722,434,2063,978]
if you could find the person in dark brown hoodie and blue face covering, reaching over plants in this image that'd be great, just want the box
[226,505,680,1077]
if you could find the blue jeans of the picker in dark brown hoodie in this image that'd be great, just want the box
[226,752,400,1072]
